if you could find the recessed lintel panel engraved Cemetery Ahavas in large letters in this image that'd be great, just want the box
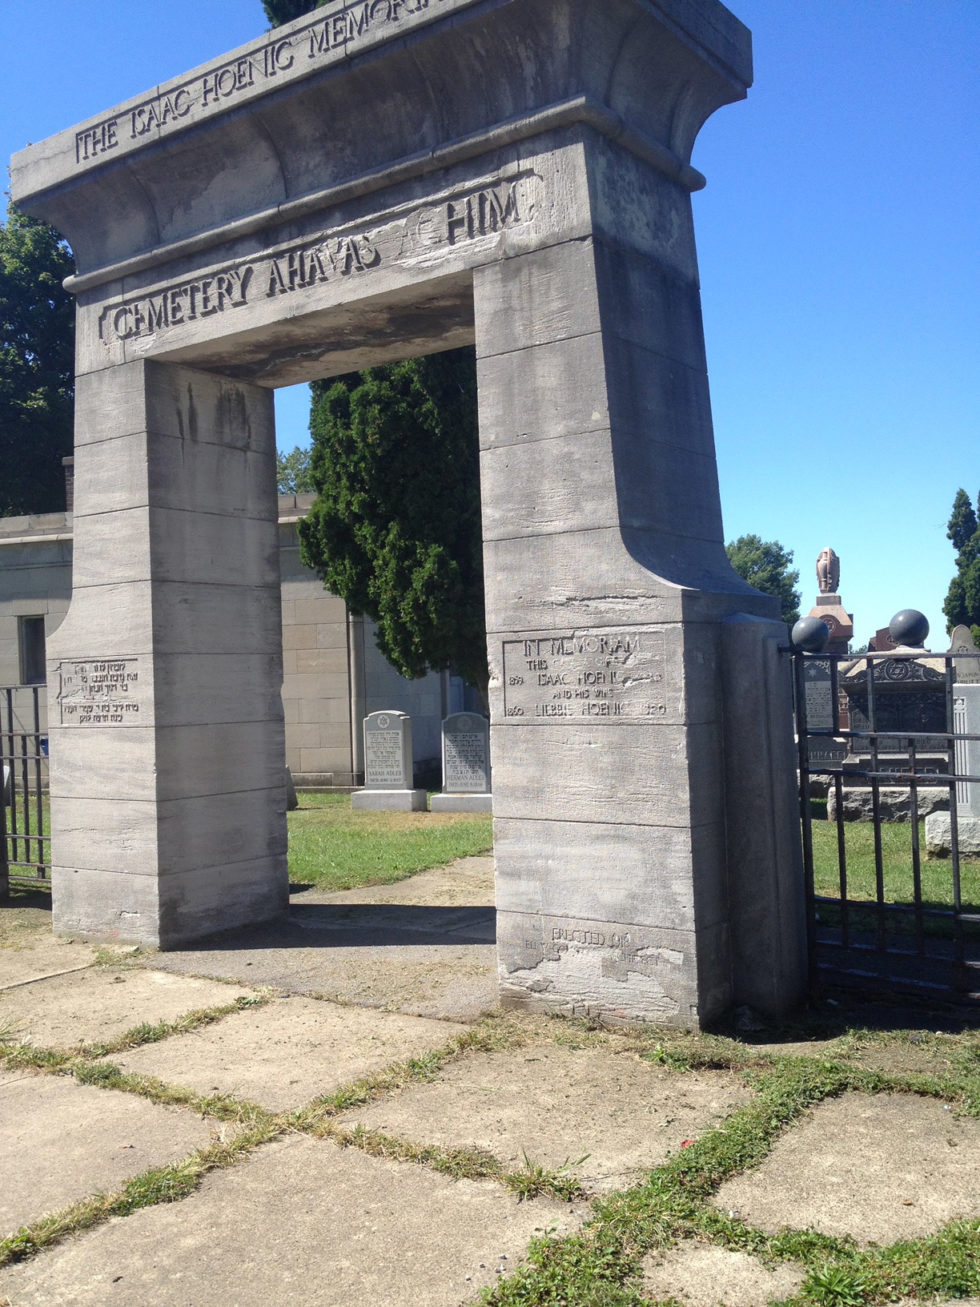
[99,173,536,344]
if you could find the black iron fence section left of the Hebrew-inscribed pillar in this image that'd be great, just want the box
[0,685,51,893]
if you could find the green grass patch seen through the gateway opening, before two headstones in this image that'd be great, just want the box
[289,793,493,890]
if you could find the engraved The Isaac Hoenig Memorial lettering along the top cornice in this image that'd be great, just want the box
[74,0,444,166]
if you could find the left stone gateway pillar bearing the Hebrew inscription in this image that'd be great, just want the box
[48,361,287,948]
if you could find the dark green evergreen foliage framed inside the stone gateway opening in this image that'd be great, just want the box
[299,349,489,694]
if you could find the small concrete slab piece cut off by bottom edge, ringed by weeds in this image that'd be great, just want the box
[643,1242,805,1307]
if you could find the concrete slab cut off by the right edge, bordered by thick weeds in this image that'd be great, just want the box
[715,1094,980,1244]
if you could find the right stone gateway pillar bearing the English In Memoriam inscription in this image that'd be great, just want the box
[476,137,805,1026]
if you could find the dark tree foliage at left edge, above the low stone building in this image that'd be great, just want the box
[0,204,74,516]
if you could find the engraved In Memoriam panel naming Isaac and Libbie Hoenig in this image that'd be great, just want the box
[503,627,668,723]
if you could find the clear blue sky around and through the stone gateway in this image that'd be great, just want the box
[0,0,980,648]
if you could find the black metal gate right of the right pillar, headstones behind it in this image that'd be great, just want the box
[792,650,980,1002]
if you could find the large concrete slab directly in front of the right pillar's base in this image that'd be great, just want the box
[341,1044,751,1192]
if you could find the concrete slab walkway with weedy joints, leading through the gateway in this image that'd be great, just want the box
[0,859,980,1307]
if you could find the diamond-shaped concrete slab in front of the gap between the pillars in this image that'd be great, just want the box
[111,997,466,1112]
